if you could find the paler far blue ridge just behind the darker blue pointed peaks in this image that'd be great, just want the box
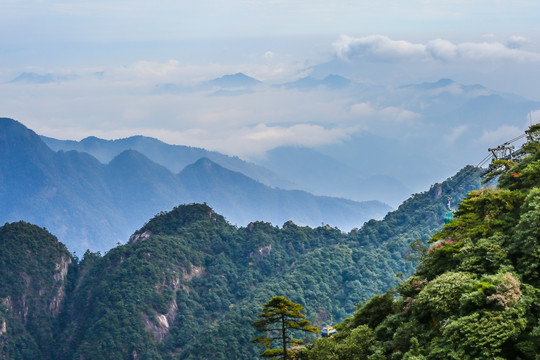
[41,131,411,204]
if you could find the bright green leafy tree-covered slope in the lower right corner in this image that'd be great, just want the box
[297,133,540,360]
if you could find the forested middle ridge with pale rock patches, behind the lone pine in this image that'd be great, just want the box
[0,162,480,359]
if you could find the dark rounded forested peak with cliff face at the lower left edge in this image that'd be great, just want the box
[0,221,72,360]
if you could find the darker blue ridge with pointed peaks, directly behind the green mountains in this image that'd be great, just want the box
[0,118,390,253]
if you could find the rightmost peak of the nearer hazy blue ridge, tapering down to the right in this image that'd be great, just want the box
[178,158,390,231]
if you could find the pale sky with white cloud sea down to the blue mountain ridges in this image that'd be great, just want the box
[0,0,540,159]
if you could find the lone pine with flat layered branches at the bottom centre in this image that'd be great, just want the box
[251,296,320,359]
